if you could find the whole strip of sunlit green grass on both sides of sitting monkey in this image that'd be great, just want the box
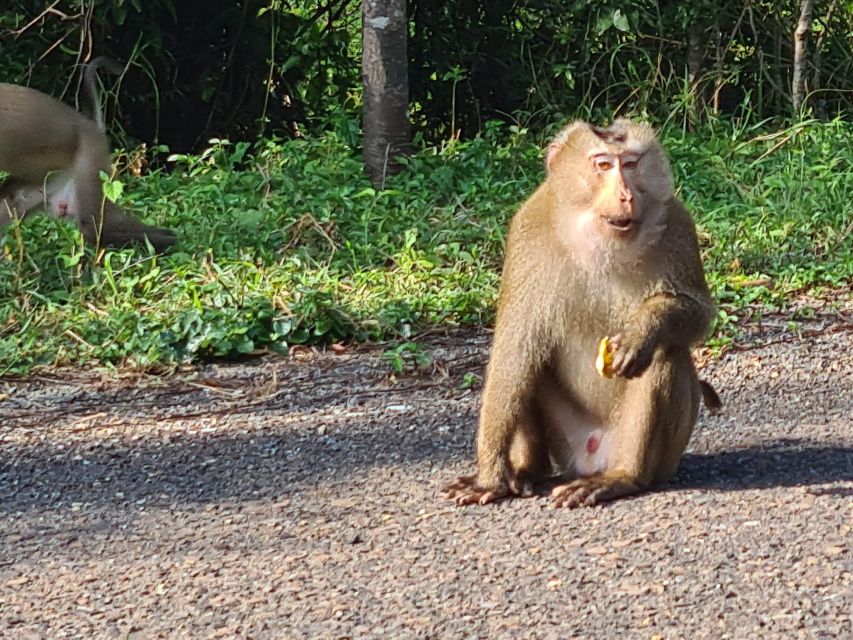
[0,120,853,373]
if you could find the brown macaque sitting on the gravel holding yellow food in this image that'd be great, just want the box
[443,119,720,507]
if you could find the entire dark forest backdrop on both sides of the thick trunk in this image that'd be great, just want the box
[0,0,853,152]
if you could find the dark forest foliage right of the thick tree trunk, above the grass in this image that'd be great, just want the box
[409,0,853,139]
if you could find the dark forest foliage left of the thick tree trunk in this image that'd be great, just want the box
[0,0,361,151]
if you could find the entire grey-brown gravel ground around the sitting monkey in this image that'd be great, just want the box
[0,324,853,640]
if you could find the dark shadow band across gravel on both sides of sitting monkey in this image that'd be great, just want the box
[0,400,853,513]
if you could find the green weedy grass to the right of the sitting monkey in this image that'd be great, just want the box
[667,120,853,290]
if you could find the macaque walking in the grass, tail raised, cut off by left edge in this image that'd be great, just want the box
[0,59,175,252]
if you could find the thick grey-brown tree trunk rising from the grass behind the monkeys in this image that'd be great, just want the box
[361,0,410,187]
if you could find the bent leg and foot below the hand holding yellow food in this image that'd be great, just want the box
[551,349,701,507]
